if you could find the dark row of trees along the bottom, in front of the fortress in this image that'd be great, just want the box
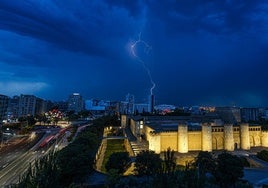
[106,149,251,188]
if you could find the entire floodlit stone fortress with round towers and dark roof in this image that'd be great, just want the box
[121,116,268,153]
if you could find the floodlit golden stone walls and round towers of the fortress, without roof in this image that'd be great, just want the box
[127,116,268,153]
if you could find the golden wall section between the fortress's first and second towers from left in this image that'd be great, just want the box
[161,132,178,151]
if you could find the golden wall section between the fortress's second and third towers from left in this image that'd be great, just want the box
[188,131,202,151]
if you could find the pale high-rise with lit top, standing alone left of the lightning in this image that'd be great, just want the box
[68,93,84,113]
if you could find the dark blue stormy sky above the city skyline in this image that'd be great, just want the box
[0,0,268,106]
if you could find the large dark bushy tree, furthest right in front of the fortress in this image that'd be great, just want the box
[213,152,244,187]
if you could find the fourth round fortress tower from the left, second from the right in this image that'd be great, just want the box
[224,124,234,151]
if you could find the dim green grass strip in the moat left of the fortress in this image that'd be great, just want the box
[101,139,127,173]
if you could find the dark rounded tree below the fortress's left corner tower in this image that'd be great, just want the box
[135,150,162,176]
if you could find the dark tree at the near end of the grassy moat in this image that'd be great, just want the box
[105,152,131,174]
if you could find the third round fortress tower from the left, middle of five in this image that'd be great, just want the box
[202,123,212,152]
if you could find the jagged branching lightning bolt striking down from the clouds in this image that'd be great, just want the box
[131,33,155,95]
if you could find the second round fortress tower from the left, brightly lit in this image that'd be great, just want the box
[178,124,188,153]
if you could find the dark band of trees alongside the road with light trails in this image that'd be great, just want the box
[14,116,118,188]
